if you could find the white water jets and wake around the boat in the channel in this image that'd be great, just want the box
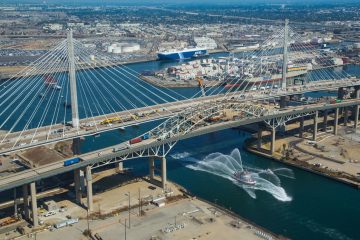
[172,148,294,202]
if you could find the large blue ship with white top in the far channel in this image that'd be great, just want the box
[158,48,208,60]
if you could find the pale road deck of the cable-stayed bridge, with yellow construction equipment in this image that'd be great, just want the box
[0,78,360,154]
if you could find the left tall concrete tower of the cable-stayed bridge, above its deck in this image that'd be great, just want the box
[67,29,79,129]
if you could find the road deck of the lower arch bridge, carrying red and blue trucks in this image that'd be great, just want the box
[0,96,360,192]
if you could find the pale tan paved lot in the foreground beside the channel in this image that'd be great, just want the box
[0,177,271,240]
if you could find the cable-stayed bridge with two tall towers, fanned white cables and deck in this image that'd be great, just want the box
[0,22,357,153]
